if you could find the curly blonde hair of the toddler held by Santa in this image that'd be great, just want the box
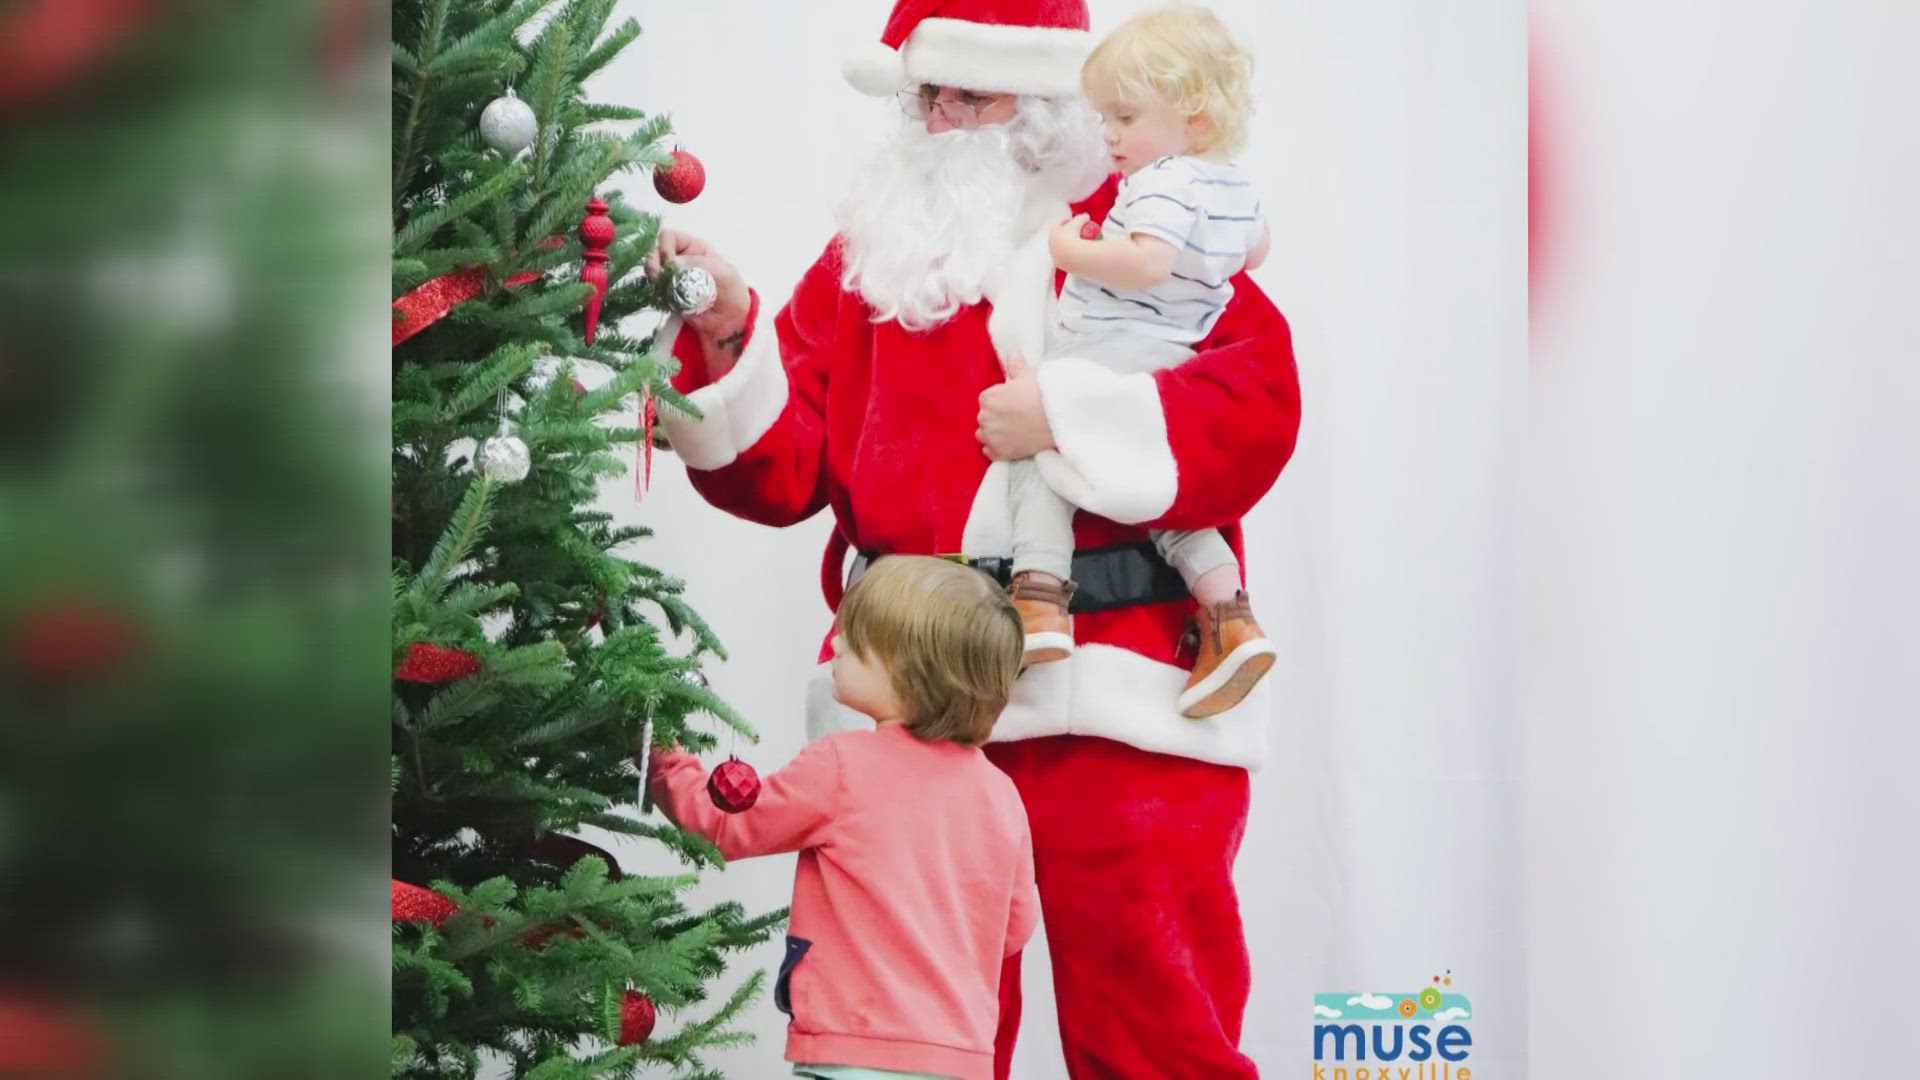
[1081,4,1254,158]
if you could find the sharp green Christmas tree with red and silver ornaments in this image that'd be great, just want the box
[392,0,783,1080]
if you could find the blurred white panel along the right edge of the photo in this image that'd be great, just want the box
[1526,0,1920,1080]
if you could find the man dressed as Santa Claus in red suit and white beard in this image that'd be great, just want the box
[651,0,1300,1080]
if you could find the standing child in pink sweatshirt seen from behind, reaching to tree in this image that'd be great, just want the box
[651,555,1039,1080]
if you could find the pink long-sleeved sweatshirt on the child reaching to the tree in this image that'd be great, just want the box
[653,724,1041,1080]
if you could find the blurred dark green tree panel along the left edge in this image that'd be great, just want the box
[0,0,388,1078]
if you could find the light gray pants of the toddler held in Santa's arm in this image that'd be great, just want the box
[1008,329,1238,590]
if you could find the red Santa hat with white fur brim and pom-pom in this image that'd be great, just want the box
[841,0,1092,96]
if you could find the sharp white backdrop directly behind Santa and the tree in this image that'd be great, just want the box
[593,0,1526,1080]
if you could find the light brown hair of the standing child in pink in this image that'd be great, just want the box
[837,555,1027,746]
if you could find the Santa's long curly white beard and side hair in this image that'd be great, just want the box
[837,98,1110,332]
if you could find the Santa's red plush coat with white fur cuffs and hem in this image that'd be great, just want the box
[662,181,1300,767]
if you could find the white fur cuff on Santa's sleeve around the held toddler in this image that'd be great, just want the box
[1035,357,1179,525]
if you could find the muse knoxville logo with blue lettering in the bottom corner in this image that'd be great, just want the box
[1313,969,1473,1080]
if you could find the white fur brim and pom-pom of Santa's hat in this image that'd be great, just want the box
[841,19,1092,98]
